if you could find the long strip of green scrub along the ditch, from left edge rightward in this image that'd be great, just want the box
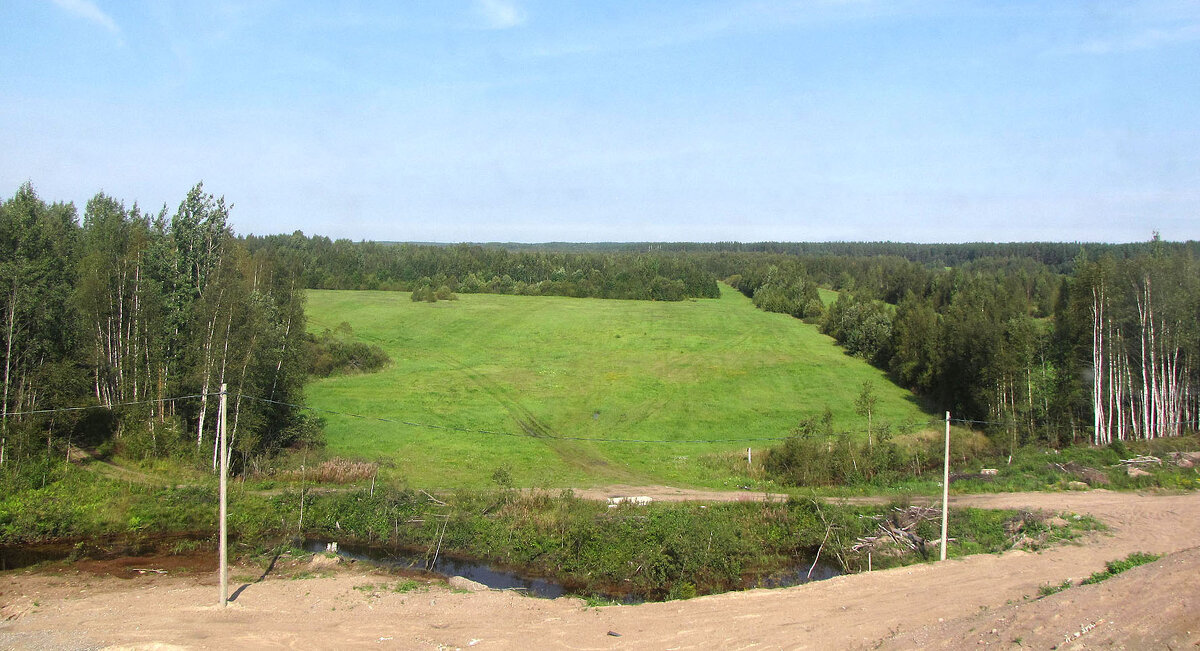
[0,472,1094,601]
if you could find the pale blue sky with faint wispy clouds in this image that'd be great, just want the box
[0,0,1200,241]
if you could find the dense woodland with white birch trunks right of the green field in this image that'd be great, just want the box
[701,238,1200,446]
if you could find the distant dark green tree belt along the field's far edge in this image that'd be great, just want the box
[242,236,720,300]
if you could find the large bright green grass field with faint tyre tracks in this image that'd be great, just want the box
[307,286,931,488]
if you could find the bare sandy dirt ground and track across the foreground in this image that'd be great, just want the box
[0,486,1200,650]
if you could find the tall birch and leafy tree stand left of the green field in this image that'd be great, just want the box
[0,184,312,473]
